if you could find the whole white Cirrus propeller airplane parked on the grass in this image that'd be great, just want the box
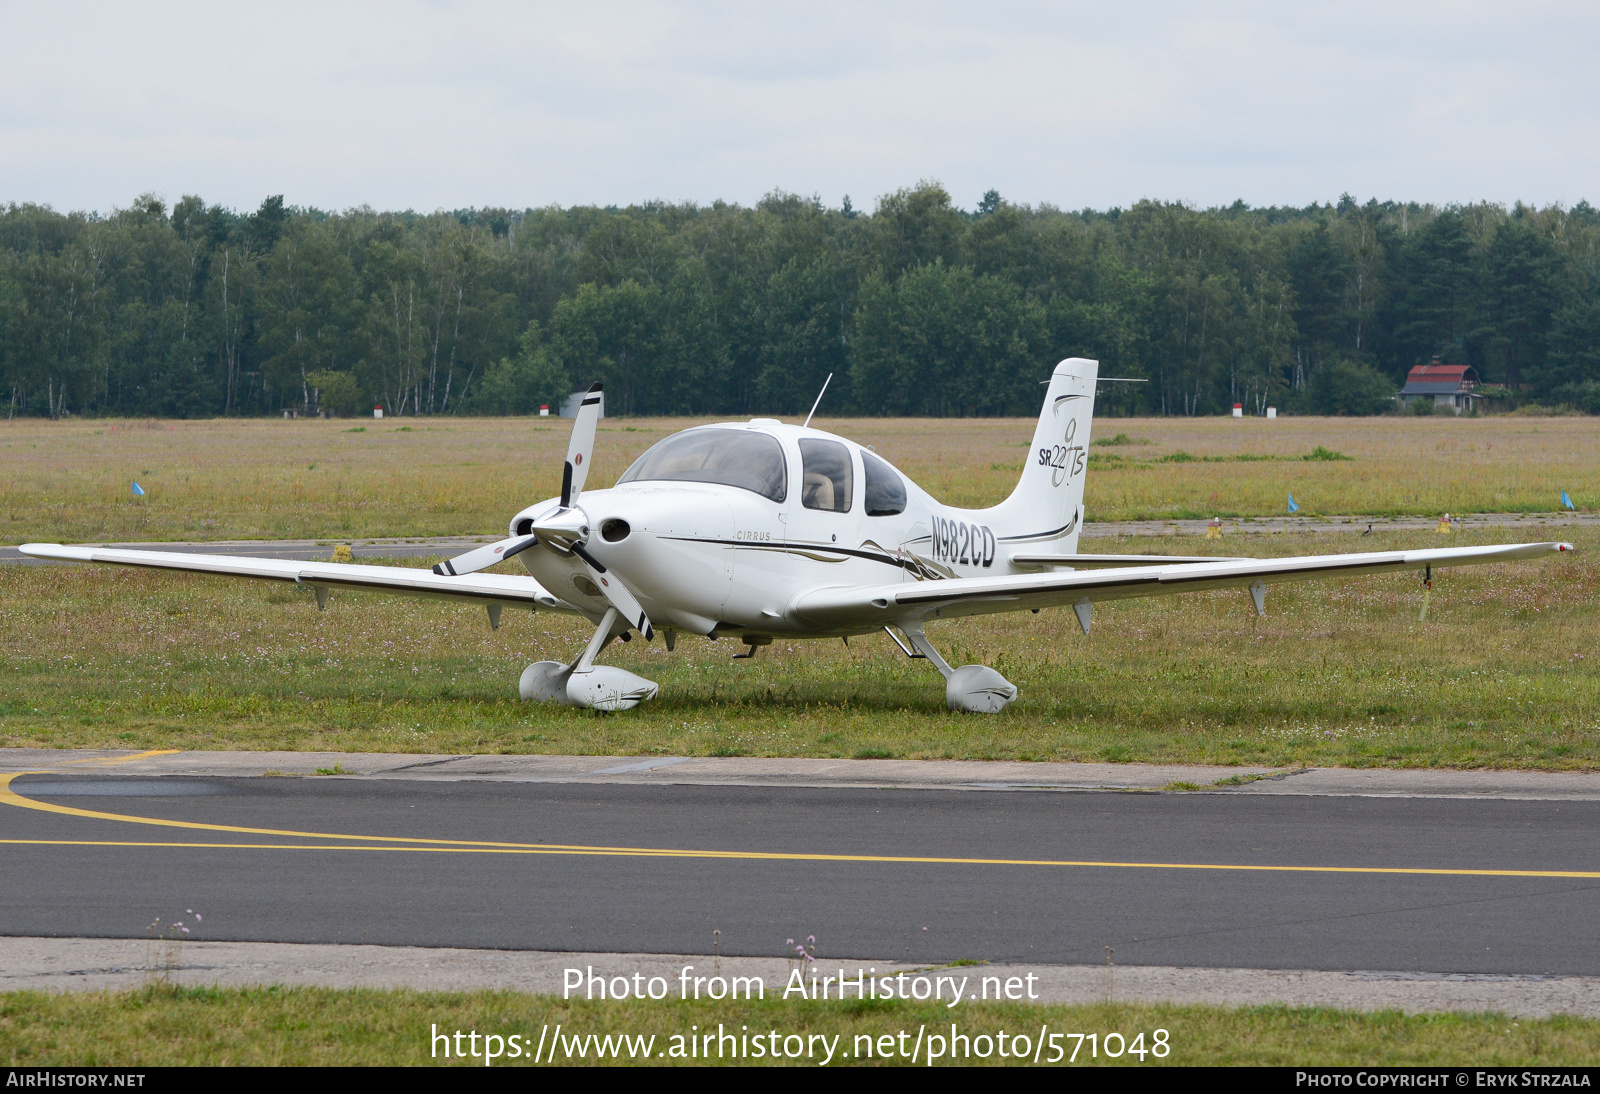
[21,358,1573,713]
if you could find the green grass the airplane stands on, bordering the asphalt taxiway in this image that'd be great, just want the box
[0,529,1600,769]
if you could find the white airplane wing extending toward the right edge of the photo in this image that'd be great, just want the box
[786,544,1573,629]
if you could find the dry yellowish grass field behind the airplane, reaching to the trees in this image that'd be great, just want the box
[0,416,1600,542]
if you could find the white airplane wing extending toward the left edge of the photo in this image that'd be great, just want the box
[18,544,576,611]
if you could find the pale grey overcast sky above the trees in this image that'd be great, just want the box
[0,0,1600,211]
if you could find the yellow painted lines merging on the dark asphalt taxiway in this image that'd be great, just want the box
[0,767,1600,880]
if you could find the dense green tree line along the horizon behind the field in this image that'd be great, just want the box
[0,182,1600,417]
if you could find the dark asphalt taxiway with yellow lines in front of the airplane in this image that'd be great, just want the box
[0,750,1600,977]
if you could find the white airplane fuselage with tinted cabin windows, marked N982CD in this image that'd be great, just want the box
[510,419,1077,641]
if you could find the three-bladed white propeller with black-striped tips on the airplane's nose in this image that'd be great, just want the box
[434,382,656,641]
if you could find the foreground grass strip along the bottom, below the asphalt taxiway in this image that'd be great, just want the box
[0,987,1600,1067]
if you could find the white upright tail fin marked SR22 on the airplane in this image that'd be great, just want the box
[989,357,1099,555]
